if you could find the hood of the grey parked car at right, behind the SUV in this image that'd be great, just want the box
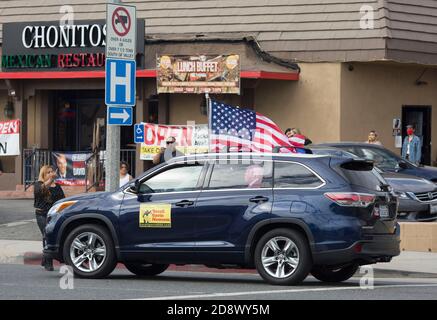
[381,172,436,193]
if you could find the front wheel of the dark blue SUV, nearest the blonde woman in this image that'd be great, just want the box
[63,224,117,279]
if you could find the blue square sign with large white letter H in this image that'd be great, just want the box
[105,59,136,107]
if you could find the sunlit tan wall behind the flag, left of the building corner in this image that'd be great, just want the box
[255,63,341,143]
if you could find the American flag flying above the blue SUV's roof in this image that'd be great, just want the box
[209,101,296,152]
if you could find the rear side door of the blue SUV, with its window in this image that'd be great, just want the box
[195,160,273,263]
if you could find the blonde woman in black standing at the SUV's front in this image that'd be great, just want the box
[33,165,65,271]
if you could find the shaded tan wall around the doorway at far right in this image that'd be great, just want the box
[340,63,437,163]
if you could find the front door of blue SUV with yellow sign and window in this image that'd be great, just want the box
[119,163,205,260]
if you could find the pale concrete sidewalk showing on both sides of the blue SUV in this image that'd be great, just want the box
[0,240,437,278]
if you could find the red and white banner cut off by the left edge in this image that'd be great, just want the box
[0,120,20,156]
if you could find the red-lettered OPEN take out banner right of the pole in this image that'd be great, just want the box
[140,123,208,160]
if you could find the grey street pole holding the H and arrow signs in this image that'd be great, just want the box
[105,0,121,192]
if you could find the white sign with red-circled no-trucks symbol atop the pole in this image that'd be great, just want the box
[106,4,137,60]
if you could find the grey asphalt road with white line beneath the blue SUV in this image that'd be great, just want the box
[0,265,437,300]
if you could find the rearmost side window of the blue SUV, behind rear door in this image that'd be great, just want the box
[274,162,323,188]
